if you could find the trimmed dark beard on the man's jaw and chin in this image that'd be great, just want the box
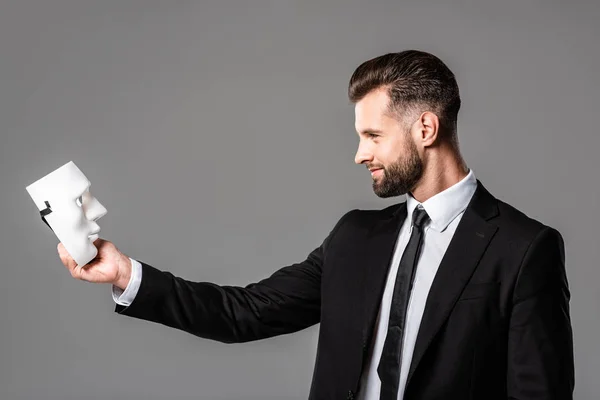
[373,137,423,198]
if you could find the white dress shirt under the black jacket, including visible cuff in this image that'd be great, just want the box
[112,169,477,400]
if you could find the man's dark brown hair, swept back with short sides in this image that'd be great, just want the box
[348,50,460,140]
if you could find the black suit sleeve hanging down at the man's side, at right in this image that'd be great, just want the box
[507,227,575,400]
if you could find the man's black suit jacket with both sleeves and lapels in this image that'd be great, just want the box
[116,181,574,400]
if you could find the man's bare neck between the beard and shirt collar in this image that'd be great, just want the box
[411,147,469,203]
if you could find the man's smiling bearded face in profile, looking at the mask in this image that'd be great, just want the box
[354,89,423,198]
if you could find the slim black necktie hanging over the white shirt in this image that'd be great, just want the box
[377,204,429,400]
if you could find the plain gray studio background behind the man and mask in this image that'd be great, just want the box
[0,0,600,400]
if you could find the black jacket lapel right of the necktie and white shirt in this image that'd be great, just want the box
[406,180,498,386]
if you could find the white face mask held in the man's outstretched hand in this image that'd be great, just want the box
[26,161,106,266]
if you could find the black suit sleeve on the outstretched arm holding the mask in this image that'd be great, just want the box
[115,211,351,343]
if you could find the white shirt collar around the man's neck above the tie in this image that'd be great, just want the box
[406,169,477,232]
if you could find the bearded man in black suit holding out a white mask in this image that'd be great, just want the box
[58,50,574,400]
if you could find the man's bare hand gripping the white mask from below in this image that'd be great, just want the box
[57,238,131,290]
